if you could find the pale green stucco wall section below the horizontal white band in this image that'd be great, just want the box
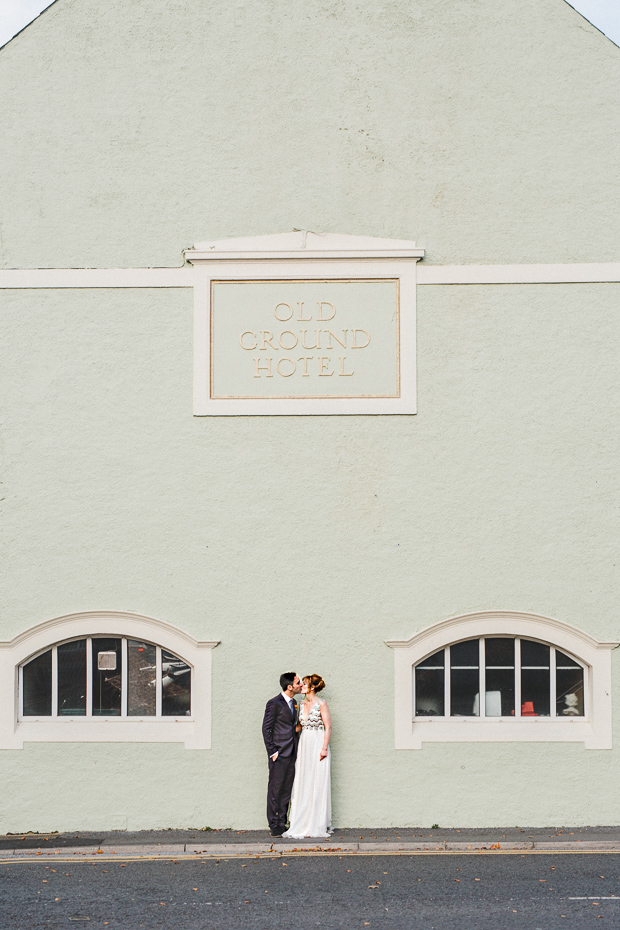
[0,285,620,830]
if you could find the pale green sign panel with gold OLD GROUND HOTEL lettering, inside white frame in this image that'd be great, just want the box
[210,278,400,400]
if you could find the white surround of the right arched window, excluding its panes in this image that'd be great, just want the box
[386,611,619,749]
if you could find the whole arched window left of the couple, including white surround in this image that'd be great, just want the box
[0,611,217,749]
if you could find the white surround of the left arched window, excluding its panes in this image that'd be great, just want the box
[0,611,218,749]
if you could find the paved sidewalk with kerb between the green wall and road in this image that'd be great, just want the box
[0,827,620,860]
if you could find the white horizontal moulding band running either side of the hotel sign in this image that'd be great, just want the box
[0,262,620,290]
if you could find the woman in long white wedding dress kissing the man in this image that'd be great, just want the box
[284,675,332,839]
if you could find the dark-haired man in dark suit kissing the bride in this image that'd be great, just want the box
[263,672,301,836]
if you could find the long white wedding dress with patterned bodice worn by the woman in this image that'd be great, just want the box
[284,701,332,840]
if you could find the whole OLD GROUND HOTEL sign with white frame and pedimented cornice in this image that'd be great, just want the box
[185,230,424,416]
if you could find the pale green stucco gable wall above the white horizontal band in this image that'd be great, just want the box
[0,0,620,267]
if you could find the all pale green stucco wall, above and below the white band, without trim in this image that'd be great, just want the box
[0,0,620,830]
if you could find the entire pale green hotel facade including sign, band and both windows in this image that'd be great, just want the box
[0,0,620,832]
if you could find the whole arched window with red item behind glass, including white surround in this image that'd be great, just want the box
[386,611,618,749]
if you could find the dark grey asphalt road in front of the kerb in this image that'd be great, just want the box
[0,853,620,930]
